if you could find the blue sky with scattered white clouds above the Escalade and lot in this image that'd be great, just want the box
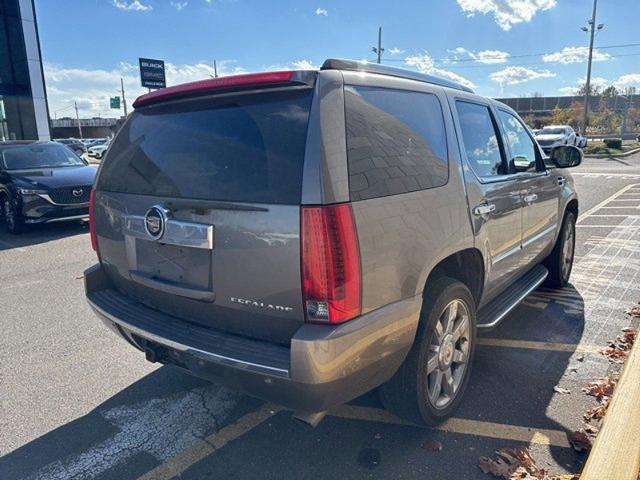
[36,0,640,117]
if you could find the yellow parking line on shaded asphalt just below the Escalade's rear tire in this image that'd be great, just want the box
[329,405,570,448]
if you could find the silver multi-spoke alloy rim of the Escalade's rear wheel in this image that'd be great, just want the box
[427,299,471,409]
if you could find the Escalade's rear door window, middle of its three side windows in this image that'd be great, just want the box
[456,101,508,177]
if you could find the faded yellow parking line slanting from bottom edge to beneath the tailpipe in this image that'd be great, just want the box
[138,404,282,480]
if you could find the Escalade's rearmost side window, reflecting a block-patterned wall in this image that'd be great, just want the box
[345,86,449,200]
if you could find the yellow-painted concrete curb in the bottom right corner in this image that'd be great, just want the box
[580,330,640,480]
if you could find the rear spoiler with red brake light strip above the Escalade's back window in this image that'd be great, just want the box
[133,70,317,108]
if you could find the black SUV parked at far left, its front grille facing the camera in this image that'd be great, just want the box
[0,141,96,234]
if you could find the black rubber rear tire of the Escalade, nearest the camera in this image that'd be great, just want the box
[378,277,476,426]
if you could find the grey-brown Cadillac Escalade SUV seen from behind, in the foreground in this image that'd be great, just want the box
[85,60,582,425]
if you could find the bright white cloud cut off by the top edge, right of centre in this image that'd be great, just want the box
[457,0,556,30]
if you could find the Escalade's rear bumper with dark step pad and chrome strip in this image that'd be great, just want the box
[85,265,422,412]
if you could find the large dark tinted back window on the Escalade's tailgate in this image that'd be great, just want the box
[97,89,312,204]
